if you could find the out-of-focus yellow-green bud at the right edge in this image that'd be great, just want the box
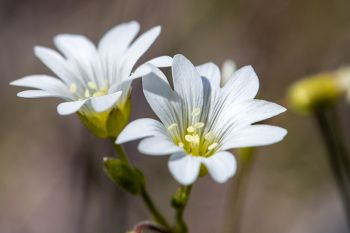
[288,72,344,113]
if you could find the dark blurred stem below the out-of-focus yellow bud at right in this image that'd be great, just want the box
[315,109,350,227]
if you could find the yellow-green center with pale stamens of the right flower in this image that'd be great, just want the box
[168,108,219,157]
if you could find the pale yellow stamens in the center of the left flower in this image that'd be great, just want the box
[69,80,108,100]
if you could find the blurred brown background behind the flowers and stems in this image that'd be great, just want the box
[0,0,350,233]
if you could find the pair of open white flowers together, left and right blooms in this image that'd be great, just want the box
[11,21,287,185]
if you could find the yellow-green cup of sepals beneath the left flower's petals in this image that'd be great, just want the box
[78,97,131,138]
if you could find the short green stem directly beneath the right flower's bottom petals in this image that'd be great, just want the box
[173,185,192,233]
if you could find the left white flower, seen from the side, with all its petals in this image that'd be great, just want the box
[11,21,172,115]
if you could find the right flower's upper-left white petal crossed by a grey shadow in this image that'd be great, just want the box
[142,67,180,127]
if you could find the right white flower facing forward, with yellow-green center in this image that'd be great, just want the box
[116,55,287,185]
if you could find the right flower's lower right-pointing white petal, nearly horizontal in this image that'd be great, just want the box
[221,125,287,150]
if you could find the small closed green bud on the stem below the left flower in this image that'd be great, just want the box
[103,158,145,195]
